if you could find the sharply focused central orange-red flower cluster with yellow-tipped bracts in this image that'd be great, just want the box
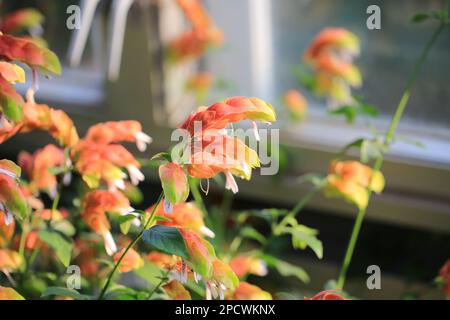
[159,97,276,211]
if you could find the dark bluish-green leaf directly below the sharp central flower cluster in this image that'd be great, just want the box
[142,225,189,259]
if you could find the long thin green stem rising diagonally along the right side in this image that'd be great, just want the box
[336,23,445,290]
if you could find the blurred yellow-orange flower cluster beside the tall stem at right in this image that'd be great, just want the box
[325,161,384,209]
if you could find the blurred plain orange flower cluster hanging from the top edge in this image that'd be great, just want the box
[167,0,223,63]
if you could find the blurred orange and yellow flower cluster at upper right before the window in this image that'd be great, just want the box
[303,28,361,105]
